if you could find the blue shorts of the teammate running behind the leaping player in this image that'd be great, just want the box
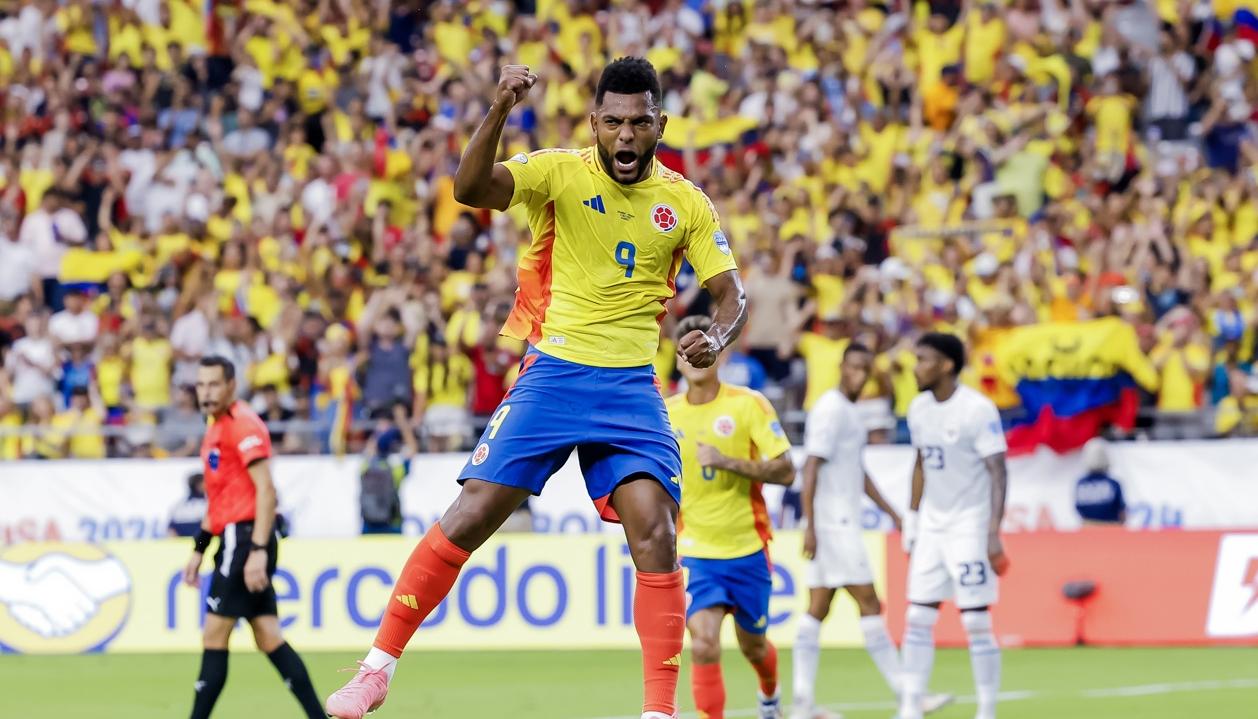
[682,549,774,634]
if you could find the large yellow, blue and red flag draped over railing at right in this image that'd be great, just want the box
[1000,317,1159,455]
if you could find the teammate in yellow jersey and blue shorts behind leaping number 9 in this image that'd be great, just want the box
[667,317,795,719]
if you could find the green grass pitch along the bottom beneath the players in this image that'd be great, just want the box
[0,647,1258,719]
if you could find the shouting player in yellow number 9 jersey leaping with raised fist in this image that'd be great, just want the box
[327,58,746,719]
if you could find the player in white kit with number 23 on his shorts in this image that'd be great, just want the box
[899,333,1009,719]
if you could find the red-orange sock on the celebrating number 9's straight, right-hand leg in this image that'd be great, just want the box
[633,569,686,716]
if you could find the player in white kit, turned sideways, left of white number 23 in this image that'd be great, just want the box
[791,342,951,719]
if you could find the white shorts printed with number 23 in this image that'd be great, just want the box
[910,532,998,610]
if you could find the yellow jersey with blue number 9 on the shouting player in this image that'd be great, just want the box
[502,147,737,367]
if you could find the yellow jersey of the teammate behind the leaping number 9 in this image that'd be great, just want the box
[665,385,790,559]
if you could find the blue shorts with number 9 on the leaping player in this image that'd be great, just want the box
[459,347,682,522]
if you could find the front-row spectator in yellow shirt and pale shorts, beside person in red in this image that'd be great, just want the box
[414,338,472,451]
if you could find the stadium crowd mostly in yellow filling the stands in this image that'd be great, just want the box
[0,0,1258,459]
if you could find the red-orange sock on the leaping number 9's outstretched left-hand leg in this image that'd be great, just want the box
[374,524,472,656]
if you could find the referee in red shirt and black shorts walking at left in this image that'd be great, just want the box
[184,357,326,719]
